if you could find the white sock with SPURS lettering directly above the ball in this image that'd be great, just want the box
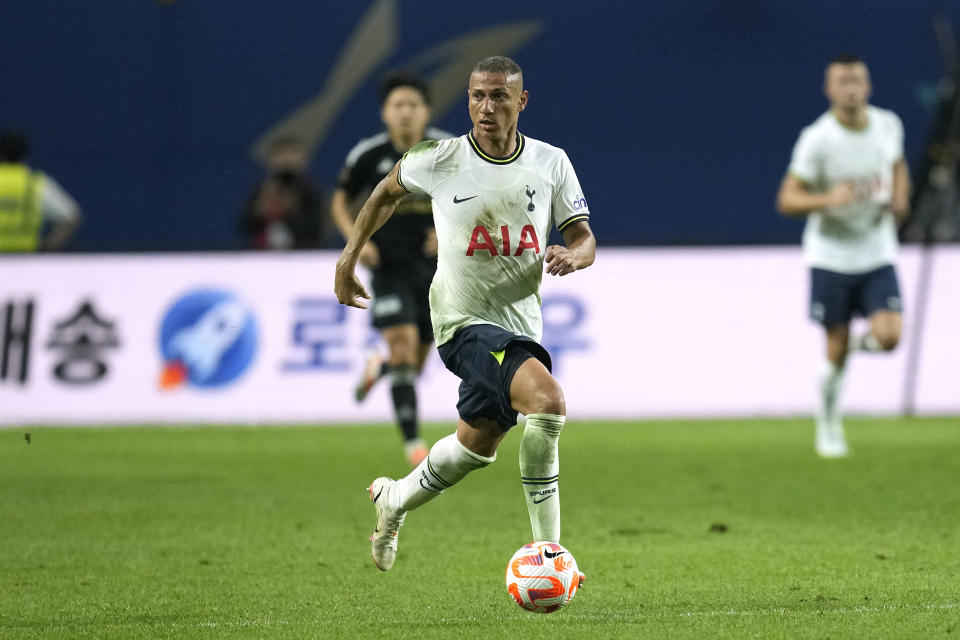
[520,413,566,542]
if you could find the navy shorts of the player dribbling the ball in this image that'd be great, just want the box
[437,324,553,431]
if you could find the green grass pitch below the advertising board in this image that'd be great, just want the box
[0,418,960,640]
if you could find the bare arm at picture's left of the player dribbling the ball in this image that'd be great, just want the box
[333,162,407,309]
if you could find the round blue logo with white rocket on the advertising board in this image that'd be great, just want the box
[160,289,257,389]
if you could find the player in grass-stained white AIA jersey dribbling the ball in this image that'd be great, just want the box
[334,56,596,571]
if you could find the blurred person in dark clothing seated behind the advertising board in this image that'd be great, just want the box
[240,137,327,250]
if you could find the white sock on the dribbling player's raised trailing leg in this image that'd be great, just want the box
[390,433,497,511]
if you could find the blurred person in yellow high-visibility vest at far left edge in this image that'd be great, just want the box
[0,130,80,252]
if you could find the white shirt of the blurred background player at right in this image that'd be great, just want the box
[790,106,903,274]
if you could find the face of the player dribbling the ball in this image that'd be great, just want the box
[467,71,528,138]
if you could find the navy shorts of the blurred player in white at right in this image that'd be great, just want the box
[810,265,903,329]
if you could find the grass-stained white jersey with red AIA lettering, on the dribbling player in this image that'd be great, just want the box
[399,133,589,345]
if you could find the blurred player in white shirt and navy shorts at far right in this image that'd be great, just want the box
[777,55,910,457]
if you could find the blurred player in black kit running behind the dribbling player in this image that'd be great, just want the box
[331,71,451,466]
